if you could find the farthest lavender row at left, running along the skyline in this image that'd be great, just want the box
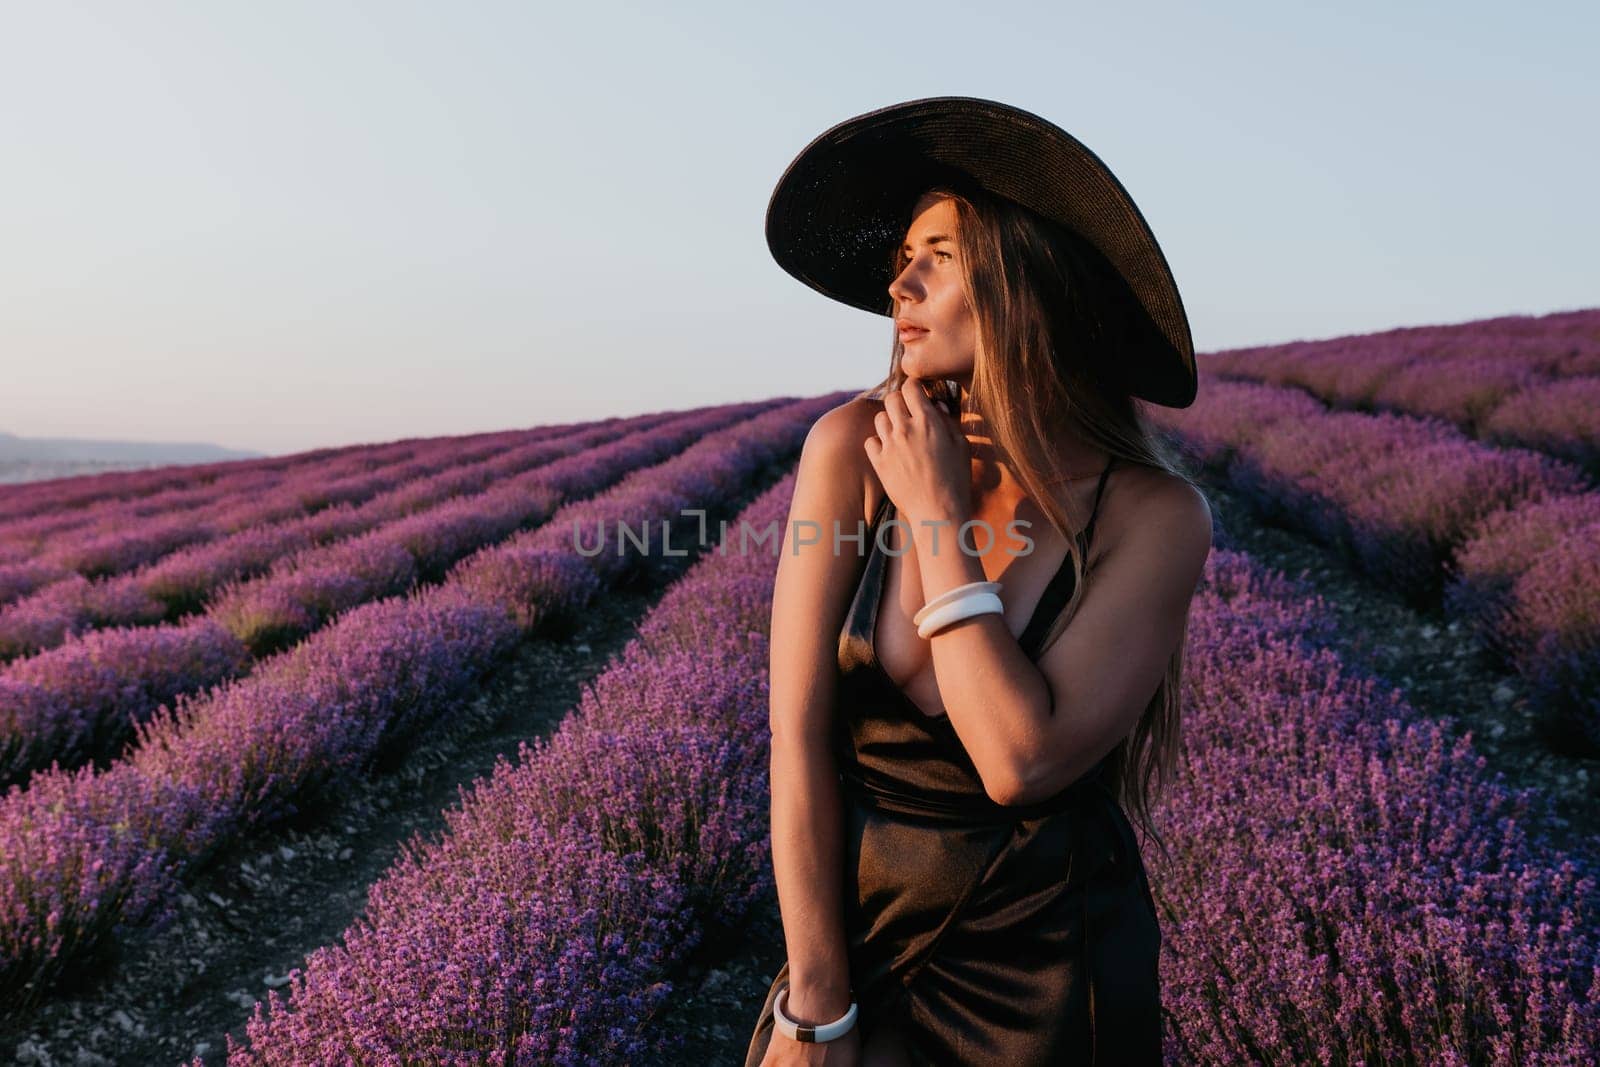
[0,419,624,607]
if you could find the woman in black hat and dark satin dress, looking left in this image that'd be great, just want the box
[746,98,1211,1067]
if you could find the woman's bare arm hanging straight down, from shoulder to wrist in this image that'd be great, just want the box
[770,400,872,1022]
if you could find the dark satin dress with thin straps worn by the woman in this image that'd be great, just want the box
[744,464,1162,1067]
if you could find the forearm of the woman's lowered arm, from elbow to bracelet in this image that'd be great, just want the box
[771,734,850,1022]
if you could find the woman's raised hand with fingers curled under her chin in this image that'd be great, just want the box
[862,378,973,530]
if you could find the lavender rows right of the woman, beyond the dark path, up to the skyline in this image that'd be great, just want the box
[1158,310,1600,757]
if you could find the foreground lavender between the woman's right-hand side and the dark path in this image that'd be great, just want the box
[1154,549,1600,1067]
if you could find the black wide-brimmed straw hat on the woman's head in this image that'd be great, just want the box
[766,96,1197,408]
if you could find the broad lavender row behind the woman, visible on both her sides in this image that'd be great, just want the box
[222,477,1600,1067]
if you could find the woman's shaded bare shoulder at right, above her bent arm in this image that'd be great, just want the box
[1094,464,1211,571]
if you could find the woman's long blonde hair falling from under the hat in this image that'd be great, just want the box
[859,186,1200,859]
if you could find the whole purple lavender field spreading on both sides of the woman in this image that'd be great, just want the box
[0,331,1600,1065]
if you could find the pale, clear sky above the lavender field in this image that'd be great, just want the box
[0,0,1600,453]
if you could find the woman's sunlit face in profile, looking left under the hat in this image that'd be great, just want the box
[890,197,978,386]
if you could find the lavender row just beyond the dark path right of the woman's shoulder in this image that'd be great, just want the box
[1152,381,1600,752]
